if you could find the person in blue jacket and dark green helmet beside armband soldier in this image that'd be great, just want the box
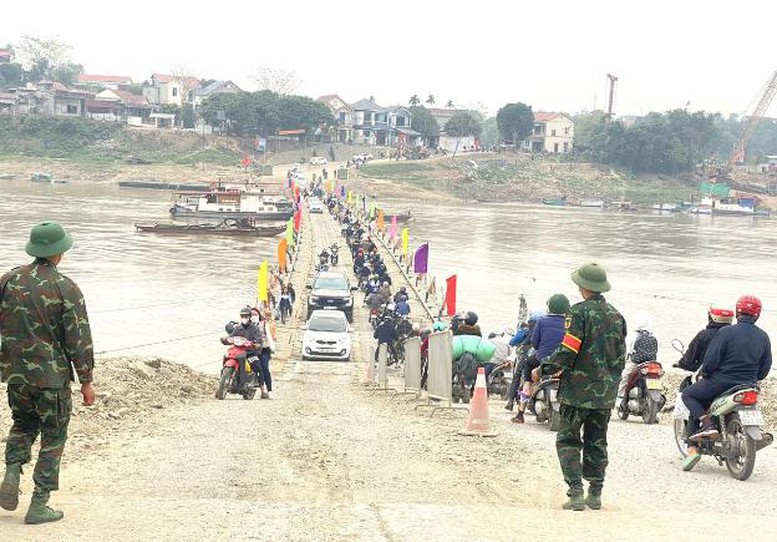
[511,294,569,423]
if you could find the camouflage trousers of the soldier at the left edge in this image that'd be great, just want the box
[5,384,73,491]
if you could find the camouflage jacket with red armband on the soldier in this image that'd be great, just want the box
[541,294,626,408]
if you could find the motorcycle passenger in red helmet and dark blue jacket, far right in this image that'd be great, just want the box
[682,295,772,471]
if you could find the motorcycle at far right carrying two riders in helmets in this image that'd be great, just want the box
[672,339,774,481]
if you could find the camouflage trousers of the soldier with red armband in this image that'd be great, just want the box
[556,404,610,496]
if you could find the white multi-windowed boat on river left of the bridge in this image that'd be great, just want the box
[170,190,294,221]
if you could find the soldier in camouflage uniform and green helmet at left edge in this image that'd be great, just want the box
[0,222,94,523]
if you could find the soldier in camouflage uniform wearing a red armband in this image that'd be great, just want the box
[534,263,626,511]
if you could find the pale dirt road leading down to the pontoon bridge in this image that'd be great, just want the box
[0,193,777,541]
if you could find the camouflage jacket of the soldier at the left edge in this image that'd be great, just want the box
[0,258,94,388]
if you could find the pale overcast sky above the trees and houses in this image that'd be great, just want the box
[0,0,777,116]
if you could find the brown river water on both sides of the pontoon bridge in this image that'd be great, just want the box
[0,180,777,372]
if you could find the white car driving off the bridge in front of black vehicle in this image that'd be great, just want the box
[302,309,351,361]
